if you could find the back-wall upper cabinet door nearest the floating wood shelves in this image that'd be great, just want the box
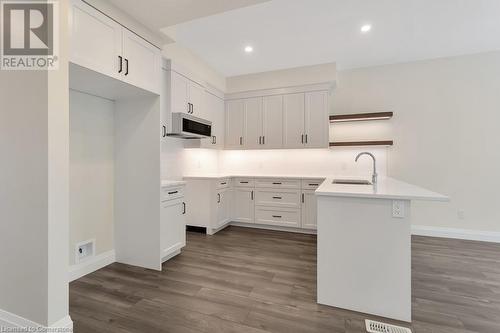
[304,91,329,148]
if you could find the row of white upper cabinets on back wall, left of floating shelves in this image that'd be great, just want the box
[225,90,330,149]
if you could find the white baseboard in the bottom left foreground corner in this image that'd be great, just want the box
[0,309,73,332]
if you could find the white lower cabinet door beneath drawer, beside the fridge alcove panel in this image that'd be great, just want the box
[160,200,186,258]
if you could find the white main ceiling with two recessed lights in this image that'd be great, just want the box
[170,0,500,76]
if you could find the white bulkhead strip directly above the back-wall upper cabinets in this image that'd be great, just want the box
[225,63,337,94]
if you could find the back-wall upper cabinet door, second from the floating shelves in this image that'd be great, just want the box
[283,93,305,148]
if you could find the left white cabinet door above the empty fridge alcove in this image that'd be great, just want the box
[70,1,122,79]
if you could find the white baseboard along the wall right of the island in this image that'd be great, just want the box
[411,225,500,243]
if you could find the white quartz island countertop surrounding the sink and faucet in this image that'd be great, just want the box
[315,177,449,201]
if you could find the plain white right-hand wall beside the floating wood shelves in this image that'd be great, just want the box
[334,52,500,231]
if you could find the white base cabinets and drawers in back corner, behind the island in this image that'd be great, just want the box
[185,177,324,235]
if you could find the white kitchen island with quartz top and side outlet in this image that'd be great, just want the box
[315,178,448,322]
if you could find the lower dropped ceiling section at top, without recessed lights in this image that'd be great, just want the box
[109,0,269,32]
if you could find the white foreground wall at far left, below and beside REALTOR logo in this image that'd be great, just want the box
[0,1,69,326]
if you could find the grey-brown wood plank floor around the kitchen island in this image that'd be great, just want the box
[70,227,500,333]
